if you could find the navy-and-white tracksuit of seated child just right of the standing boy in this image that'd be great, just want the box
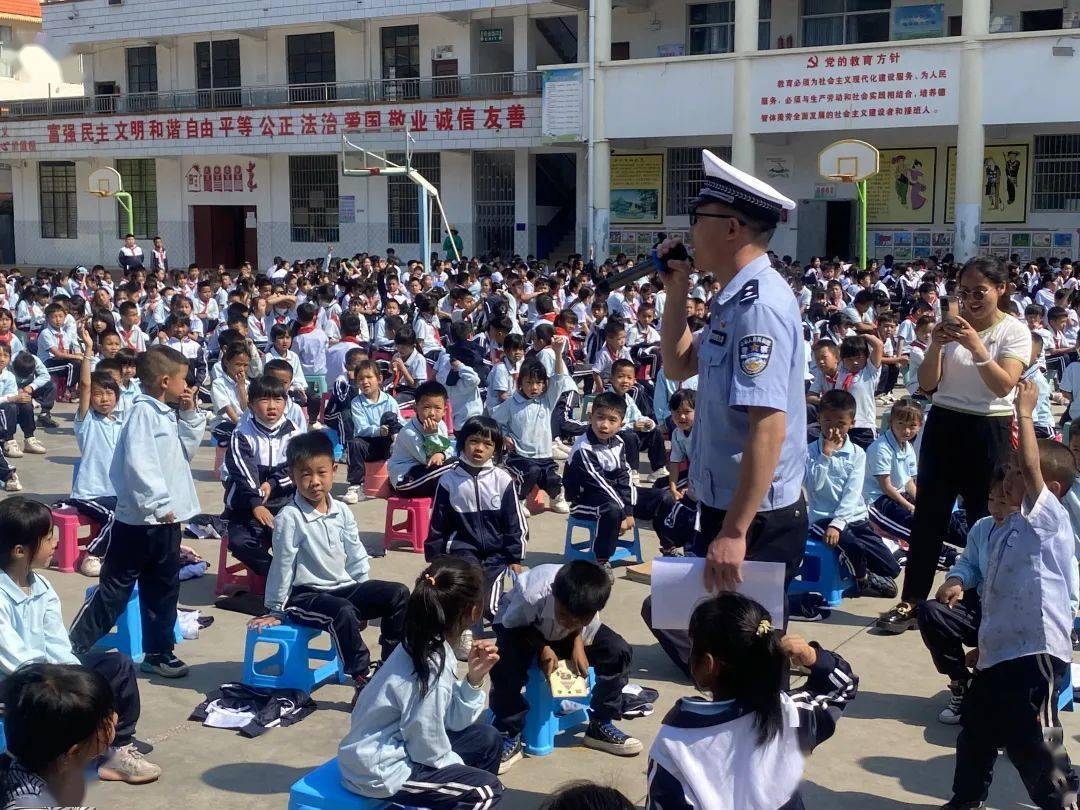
[221,411,300,577]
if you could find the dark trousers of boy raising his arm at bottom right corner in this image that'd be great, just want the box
[953,653,1077,810]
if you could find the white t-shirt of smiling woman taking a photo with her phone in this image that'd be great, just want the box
[933,315,1031,416]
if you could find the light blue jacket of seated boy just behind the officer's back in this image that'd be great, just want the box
[806,437,869,531]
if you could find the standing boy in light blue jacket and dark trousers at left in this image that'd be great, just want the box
[71,346,206,678]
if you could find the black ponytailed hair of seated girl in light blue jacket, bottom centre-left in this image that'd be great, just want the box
[403,556,484,697]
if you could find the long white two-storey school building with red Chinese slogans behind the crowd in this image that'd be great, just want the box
[0,0,1080,267]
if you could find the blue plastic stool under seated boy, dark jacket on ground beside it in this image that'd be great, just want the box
[242,624,345,694]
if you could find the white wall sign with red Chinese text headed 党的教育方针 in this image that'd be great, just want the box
[752,44,960,132]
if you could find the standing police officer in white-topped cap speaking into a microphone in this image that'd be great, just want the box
[643,150,808,670]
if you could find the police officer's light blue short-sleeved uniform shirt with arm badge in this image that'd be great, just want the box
[690,255,807,512]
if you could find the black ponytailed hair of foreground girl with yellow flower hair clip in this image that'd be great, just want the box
[690,593,787,745]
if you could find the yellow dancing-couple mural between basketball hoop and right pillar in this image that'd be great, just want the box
[866,147,937,225]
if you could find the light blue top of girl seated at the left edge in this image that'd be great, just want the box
[0,571,78,681]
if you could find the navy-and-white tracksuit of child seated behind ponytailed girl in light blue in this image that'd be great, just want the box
[423,460,529,620]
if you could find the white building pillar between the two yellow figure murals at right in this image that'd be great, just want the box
[953,0,990,261]
